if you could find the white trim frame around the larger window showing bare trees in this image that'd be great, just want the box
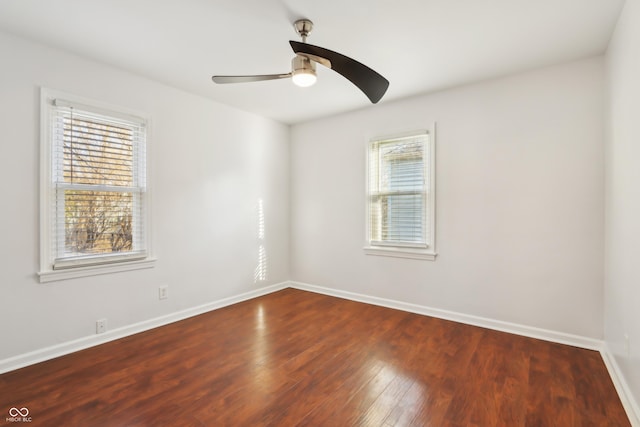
[38,87,156,283]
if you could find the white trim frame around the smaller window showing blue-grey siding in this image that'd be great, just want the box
[363,123,438,261]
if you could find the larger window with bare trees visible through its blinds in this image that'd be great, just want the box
[40,89,151,281]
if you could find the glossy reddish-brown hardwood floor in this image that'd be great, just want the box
[0,289,630,427]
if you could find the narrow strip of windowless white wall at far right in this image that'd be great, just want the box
[604,1,640,417]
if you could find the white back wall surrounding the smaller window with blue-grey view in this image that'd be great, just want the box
[291,58,604,339]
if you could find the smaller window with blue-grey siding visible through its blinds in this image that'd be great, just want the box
[365,130,436,260]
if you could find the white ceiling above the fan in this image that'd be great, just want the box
[0,0,624,123]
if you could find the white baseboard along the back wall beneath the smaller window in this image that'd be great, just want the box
[289,282,603,351]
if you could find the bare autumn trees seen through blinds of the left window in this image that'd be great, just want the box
[63,110,135,255]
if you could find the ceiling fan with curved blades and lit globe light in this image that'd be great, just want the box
[212,19,389,104]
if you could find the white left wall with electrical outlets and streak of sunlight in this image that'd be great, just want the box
[0,34,289,361]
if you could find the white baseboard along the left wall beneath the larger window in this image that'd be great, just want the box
[0,282,289,374]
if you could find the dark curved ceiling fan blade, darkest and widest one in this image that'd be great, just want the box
[289,40,389,104]
